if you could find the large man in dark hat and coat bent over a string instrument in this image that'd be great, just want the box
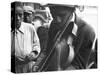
[37,4,95,71]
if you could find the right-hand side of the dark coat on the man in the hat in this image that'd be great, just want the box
[72,16,95,69]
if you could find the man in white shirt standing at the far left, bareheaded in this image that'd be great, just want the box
[11,2,41,73]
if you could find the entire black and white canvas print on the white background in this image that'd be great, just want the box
[11,1,98,73]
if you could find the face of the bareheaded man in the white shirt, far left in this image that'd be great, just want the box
[15,6,23,28]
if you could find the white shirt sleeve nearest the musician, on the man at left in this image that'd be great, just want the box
[32,26,41,57]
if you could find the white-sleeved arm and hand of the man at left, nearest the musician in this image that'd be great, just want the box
[28,26,41,60]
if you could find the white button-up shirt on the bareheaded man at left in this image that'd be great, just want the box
[12,22,40,58]
